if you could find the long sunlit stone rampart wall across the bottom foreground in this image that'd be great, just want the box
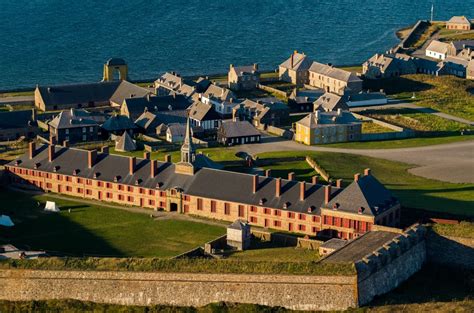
[0,270,357,310]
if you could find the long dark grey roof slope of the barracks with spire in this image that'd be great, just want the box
[8,145,348,214]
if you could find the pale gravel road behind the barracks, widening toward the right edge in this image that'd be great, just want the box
[233,137,474,183]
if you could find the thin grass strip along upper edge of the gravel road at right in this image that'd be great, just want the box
[324,135,474,149]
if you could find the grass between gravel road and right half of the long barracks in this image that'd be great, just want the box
[258,151,474,217]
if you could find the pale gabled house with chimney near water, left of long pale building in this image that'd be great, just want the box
[278,51,311,86]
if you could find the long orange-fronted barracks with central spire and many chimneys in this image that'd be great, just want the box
[5,122,400,239]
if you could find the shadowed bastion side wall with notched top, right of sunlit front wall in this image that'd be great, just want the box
[355,226,426,306]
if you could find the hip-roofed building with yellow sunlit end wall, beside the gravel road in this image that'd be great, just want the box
[295,109,362,145]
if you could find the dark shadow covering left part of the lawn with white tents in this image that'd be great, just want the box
[0,185,127,257]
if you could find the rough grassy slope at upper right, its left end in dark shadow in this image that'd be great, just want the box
[365,74,474,121]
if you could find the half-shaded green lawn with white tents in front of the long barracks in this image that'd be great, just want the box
[0,191,225,257]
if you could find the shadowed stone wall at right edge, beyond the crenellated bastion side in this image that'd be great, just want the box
[426,231,474,269]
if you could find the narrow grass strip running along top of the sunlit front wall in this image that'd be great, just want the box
[0,258,356,275]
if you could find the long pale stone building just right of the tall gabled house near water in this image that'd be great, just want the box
[308,62,362,95]
